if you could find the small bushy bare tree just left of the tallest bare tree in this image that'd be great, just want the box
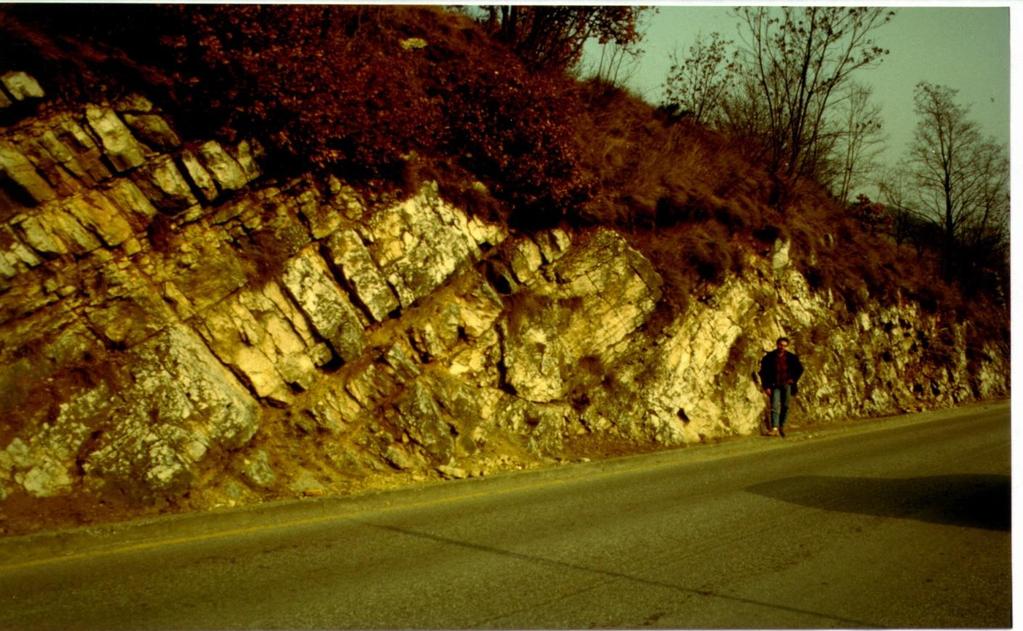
[664,33,737,126]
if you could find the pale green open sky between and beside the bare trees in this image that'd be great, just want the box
[584,1,1010,170]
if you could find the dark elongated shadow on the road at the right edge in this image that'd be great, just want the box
[746,475,1012,531]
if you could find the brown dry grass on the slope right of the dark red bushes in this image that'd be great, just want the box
[572,82,1008,355]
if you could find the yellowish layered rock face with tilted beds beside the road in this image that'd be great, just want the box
[0,73,1009,527]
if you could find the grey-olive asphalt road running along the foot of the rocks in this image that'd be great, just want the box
[0,404,1012,630]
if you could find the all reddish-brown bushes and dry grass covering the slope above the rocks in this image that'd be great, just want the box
[0,5,1008,355]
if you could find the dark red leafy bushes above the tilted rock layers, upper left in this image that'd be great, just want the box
[3,4,589,226]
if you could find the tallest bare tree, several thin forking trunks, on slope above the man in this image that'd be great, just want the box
[737,6,894,180]
